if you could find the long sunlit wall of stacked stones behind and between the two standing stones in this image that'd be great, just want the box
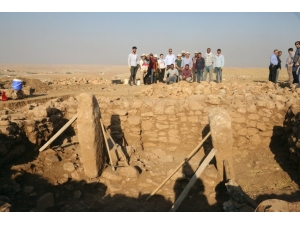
[98,82,299,155]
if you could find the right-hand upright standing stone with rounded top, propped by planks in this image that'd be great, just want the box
[208,107,234,179]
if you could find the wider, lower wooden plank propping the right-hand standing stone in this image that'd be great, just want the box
[169,148,217,212]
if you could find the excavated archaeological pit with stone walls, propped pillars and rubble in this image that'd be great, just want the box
[0,74,300,212]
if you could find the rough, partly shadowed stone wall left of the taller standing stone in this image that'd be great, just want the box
[0,97,77,165]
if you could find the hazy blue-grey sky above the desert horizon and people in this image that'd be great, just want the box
[0,12,300,67]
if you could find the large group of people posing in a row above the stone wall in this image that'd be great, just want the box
[128,46,225,85]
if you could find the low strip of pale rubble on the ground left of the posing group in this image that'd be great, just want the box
[48,77,111,85]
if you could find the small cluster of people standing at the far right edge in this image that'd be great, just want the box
[269,41,300,84]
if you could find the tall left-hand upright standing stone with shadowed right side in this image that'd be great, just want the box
[77,93,104,178]
